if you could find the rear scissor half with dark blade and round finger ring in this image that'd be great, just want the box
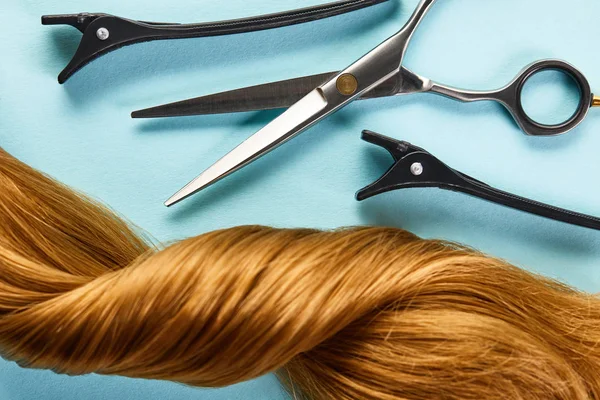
[133,60,600,136]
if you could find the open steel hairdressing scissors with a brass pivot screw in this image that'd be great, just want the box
[132,0,600,206]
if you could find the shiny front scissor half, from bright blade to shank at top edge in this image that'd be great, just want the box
[165,0,436,206]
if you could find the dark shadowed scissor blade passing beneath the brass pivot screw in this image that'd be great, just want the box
[131,72,400,118]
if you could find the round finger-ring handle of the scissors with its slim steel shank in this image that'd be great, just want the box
[431,60,594,136]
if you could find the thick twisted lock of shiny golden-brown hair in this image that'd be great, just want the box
[0,151,600,400]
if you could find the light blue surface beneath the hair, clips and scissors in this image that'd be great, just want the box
[0,0,600,400]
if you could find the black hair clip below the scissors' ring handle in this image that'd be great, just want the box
[356,131,600,230]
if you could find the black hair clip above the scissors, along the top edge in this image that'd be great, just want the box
[42,0,387,83]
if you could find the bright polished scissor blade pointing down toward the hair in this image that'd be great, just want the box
[165,89,327,207]
